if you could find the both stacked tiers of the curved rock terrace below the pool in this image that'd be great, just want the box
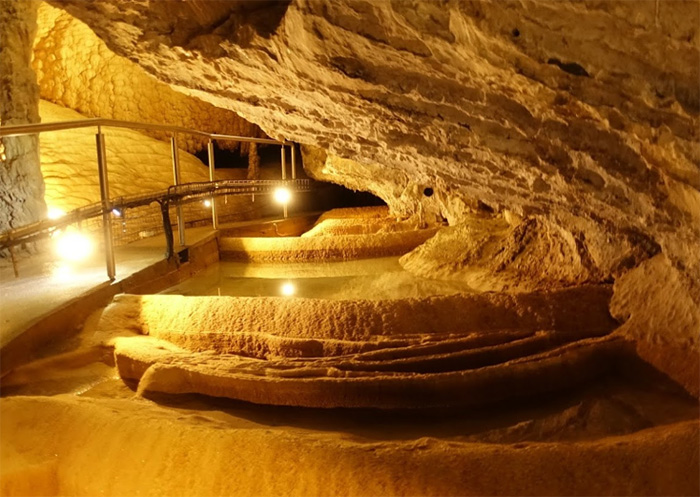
[100,287,624,408]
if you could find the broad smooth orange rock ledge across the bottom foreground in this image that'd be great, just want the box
[0,394,700,496]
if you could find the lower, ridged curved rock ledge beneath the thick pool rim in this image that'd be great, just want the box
[115,337,623,409]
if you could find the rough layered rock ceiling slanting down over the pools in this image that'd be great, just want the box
[52,0,700,391]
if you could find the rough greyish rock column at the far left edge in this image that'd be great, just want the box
[0,0,46,232]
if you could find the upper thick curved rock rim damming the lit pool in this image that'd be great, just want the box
[99,286,617,350]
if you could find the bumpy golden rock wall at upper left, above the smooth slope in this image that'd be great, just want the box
[32,2,265,153]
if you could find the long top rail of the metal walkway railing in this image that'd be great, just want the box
[0,117,291,145]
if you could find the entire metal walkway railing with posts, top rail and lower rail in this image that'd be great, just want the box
[0,118,310,280]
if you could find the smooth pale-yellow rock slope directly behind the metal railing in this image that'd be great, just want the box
[40,100,271,243]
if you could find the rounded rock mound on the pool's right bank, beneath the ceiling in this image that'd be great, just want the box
[401,213,600,292]
